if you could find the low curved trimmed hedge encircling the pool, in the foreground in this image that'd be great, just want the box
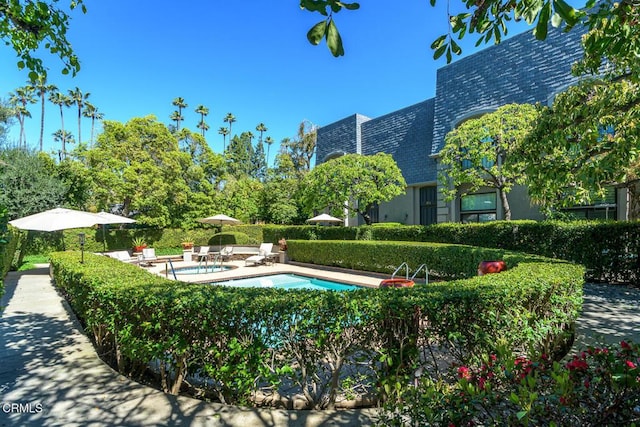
[51,242,583,408]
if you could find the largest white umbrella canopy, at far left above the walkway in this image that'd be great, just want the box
[9,208,100,231]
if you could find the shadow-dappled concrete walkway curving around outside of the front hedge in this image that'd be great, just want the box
[0,268,640,427]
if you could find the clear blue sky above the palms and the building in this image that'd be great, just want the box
[0,0,544,163]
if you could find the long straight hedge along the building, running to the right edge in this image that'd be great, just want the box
[264,220,640,285]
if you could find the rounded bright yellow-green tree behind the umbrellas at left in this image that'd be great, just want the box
[87,116,190,227]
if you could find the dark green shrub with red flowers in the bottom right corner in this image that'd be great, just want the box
[382,341,640,426]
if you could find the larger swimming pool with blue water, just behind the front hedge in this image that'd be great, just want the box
[211,274,360,291]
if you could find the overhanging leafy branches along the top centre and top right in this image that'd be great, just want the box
[300,0,640,75]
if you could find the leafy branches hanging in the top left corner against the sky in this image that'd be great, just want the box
[0,0,86,80]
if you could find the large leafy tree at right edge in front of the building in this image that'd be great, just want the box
[521,79,640,219]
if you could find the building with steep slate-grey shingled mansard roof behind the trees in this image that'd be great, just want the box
[316,28,626,225]
